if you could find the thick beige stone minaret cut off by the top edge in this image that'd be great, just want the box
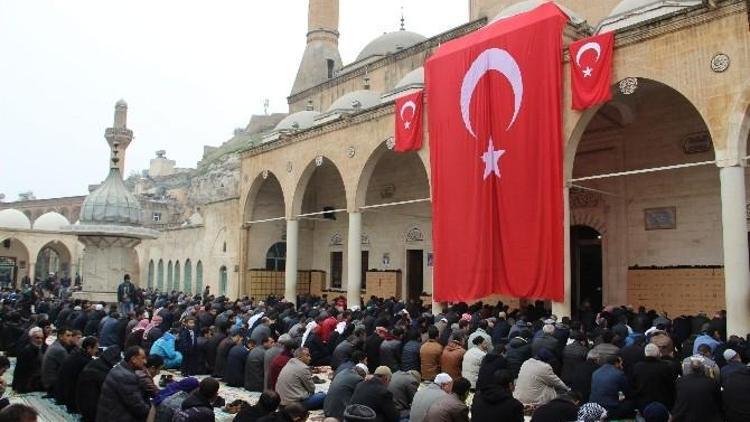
[290,0,341,99]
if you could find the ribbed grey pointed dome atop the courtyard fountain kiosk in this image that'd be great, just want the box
[81,168,141,226]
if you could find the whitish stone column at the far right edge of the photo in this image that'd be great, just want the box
[719,166,750,336]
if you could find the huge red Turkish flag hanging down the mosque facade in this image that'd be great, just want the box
[425,2,567,301]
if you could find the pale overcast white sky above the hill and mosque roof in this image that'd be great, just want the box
[0,0,468,201]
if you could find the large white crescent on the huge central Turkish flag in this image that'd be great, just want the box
[461,48,523,138]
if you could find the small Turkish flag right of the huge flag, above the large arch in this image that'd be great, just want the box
[568,32,615,110]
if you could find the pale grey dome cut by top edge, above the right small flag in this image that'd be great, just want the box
[597,0,703,32]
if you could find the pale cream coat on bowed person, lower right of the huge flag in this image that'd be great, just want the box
[513,358,570,406]
